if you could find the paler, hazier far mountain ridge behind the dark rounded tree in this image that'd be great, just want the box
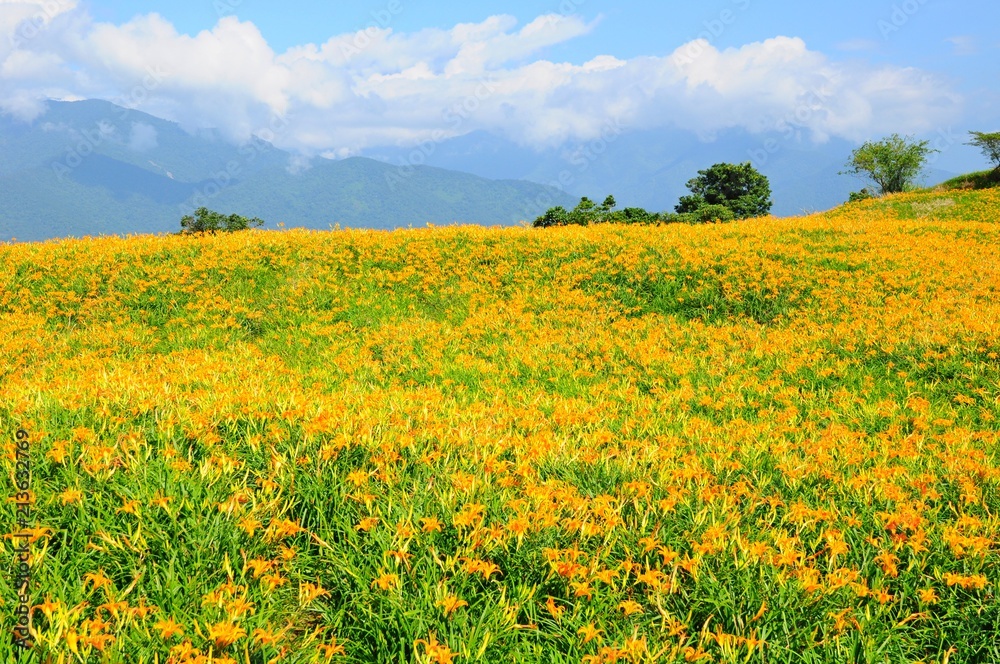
[365,128,954,216]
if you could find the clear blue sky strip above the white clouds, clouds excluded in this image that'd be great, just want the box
[88,0,1000,68]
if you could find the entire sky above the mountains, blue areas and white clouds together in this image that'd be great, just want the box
[0,0,1000,171]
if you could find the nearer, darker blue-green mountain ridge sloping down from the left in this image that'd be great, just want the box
[0,100,575,241]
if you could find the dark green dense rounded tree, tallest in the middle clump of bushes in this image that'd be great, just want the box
[675,162,772,219]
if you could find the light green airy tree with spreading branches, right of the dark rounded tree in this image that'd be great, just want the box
[844,134,938,196]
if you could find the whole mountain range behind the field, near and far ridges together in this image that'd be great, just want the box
[0,100,954,241]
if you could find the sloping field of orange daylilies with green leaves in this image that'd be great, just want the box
[0,191,1000,664]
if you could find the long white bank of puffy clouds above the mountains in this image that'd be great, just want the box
[0,0,963,156]
